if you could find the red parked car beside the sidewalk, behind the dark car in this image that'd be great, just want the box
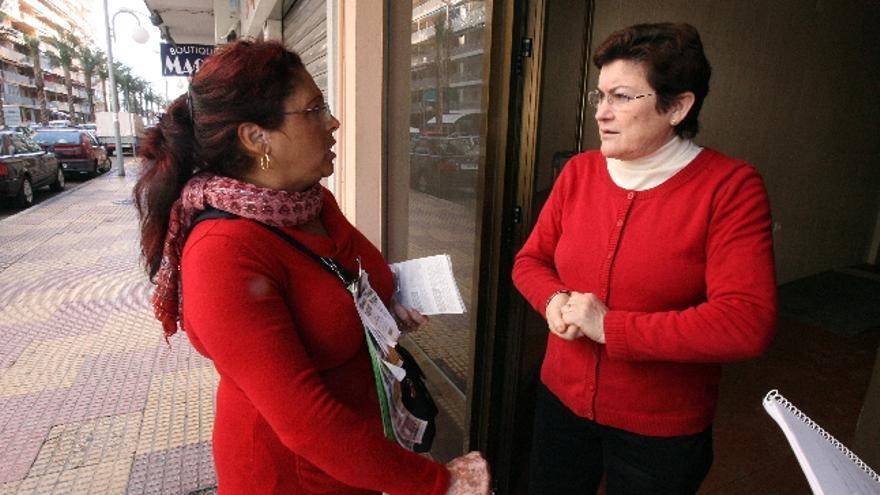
[34,128,110,176]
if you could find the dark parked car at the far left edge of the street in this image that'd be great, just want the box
[0,131,64,208]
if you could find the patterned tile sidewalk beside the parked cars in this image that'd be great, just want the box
[0,164,217,495]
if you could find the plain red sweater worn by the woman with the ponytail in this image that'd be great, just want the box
[181,191,449,495]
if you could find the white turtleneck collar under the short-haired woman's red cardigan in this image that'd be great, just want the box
[606,136,703,191]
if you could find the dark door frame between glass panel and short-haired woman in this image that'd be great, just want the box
[467,0,593,494]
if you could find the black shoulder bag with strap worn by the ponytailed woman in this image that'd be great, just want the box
[190,208,439,453]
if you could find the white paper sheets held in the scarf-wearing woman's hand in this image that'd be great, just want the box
[391,254,466,315]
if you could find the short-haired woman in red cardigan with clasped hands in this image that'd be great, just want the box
[513,23,776,494]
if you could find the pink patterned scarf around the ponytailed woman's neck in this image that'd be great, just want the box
[153,173,323,338]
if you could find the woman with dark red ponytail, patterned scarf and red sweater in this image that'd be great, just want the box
[135,41,489,495]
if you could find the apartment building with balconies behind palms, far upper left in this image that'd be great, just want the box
[0,0,104,123]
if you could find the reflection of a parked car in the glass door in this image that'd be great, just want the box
[409,136,480,200]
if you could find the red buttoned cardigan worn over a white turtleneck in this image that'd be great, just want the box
[513,149,776,436]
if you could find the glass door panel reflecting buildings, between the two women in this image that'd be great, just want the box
[385,0,491,461]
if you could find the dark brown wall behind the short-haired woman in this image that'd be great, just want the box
[584,0,880,283]
